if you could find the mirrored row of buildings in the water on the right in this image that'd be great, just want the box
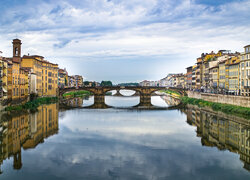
[185,106,250,170]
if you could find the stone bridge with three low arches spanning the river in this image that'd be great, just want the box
[59,86,185,108]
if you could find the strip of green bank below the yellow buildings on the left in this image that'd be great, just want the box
[4,97,58,111]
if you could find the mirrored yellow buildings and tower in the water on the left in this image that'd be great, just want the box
[0,104,58,173]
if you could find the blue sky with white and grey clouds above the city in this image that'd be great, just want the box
[0,0,250,83]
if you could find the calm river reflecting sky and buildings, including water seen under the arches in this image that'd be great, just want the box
[0,91,250,180]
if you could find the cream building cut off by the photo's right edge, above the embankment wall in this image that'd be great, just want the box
[240,45,250,96]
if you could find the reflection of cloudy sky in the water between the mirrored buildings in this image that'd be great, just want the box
[4,105,249,179]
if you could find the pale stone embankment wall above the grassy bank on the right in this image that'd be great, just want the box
[187,91,250,108]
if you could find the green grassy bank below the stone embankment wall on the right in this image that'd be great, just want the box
[180,96,250,119]
